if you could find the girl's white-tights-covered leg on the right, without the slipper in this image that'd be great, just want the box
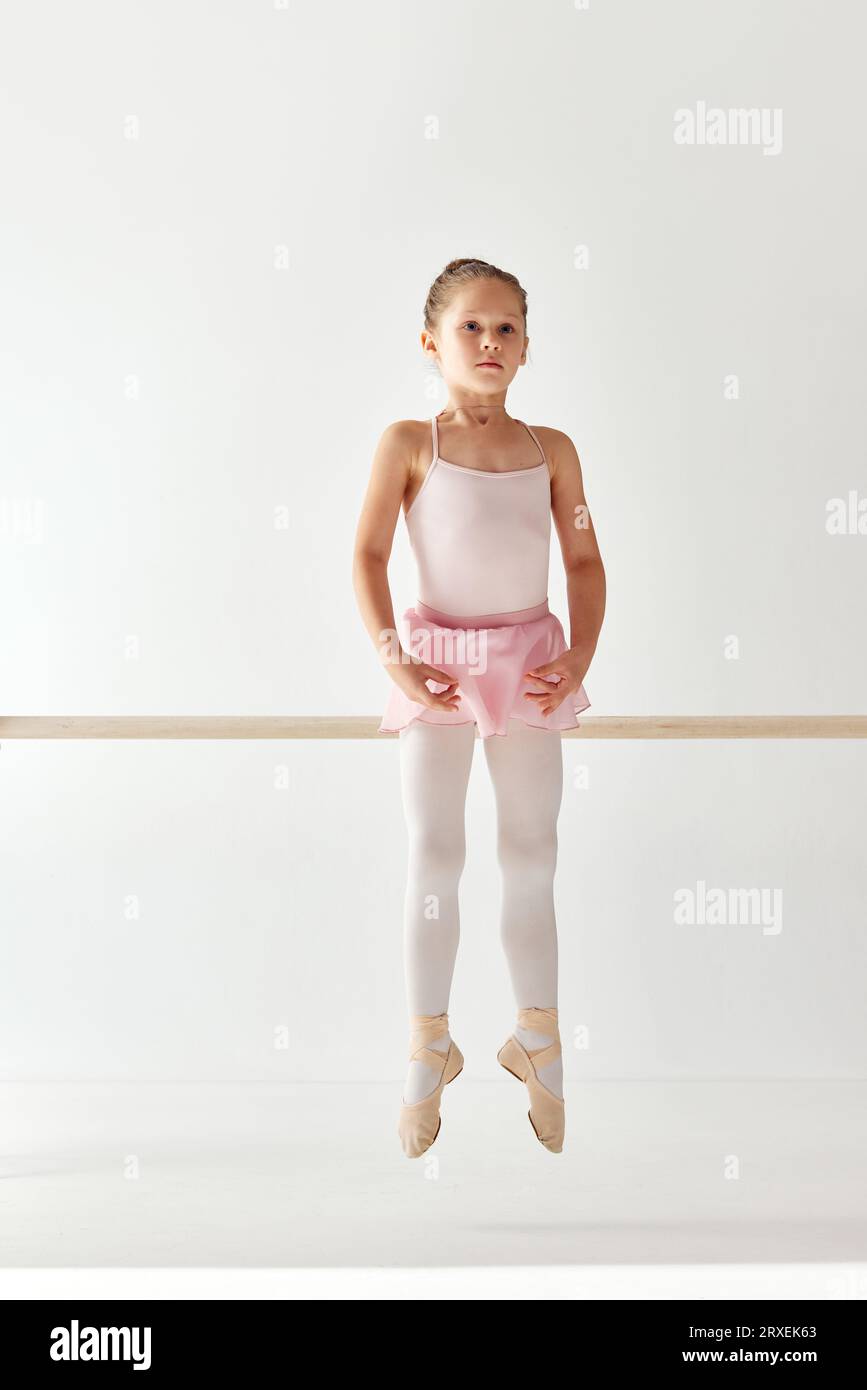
[484,719,563,1097]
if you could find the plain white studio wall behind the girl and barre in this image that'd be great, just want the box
[0,0,867,1079]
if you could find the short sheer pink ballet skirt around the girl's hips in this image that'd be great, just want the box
[377,599,591,738]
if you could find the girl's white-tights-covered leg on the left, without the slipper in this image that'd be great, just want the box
[399,720,475,1105]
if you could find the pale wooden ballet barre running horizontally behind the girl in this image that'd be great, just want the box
[0,714,867,742]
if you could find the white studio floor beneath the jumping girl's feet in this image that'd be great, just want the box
[0,1076,867,1298]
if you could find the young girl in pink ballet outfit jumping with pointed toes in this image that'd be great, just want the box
[353,260,606,1158]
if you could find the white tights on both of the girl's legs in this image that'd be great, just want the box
[400,719,563,1104]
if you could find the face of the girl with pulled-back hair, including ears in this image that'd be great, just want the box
[421,279,529,398]
